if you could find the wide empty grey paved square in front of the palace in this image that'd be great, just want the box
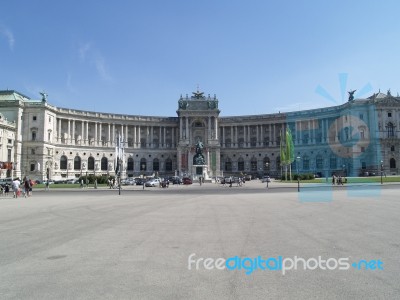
[0,182,400,299]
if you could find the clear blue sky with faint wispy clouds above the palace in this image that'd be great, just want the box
[0,0,400,116]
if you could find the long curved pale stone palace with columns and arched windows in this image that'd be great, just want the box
[0,90,400,180]
